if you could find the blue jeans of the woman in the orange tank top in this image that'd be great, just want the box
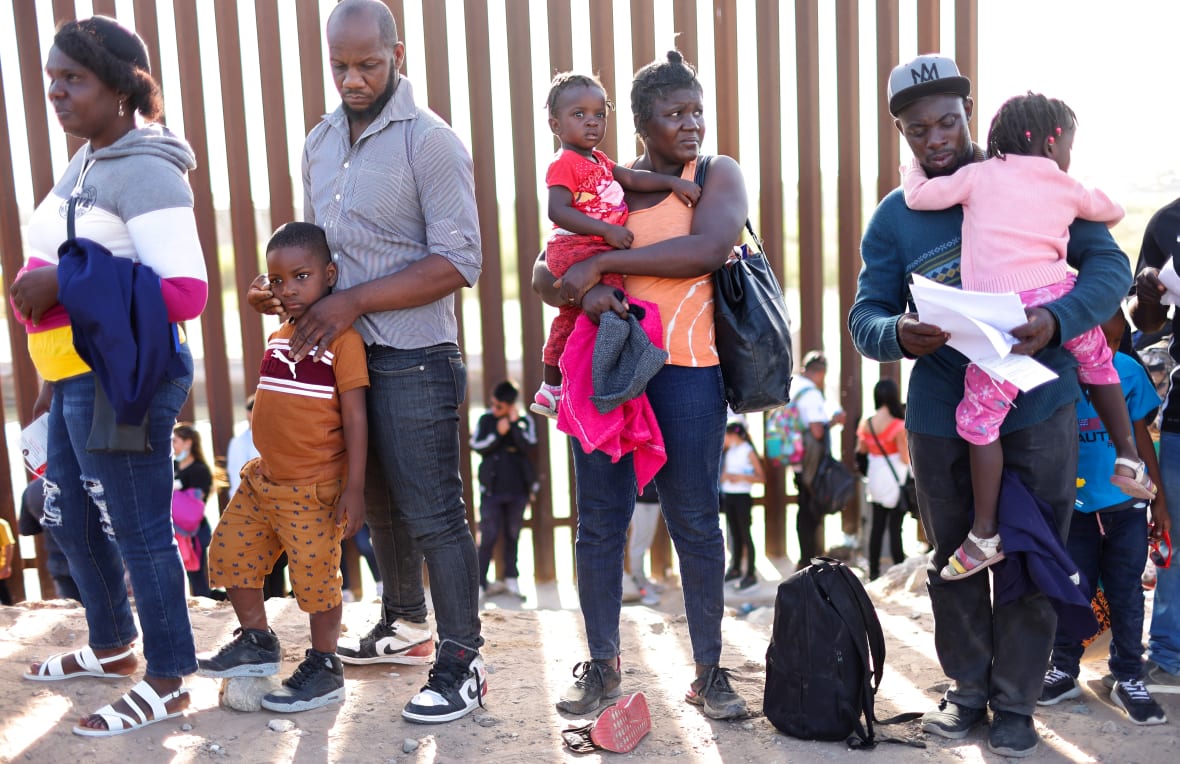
[571,366,726,666]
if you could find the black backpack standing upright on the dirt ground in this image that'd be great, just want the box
[763,557,925,749]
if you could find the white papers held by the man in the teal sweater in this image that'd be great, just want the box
[910,274,1057,392]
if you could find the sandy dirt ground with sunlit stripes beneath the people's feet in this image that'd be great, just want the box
[0,557,1180,764]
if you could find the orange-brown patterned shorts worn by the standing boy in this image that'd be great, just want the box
[209,459,343,613]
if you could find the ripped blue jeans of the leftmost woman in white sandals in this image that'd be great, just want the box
[44,345,197,678]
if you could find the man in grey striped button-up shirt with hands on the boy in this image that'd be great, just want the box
[251,0,487,723]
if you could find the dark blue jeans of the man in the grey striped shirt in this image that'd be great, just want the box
[365,344,484,648]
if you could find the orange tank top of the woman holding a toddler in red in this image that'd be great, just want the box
[624,159,719,366]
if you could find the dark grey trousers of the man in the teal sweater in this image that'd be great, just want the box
[909,404,1077,716]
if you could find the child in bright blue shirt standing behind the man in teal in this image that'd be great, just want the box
[1037,309,1168,724]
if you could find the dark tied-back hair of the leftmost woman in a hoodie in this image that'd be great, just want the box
[53,15,164,122]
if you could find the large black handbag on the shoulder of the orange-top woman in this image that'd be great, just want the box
[695,156,794,413]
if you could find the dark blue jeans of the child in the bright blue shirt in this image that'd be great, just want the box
[1053,509,1147,680]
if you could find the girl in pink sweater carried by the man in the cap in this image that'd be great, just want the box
[902,92,1155,580]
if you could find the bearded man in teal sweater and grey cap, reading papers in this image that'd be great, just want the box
[848,54,1130,757]
